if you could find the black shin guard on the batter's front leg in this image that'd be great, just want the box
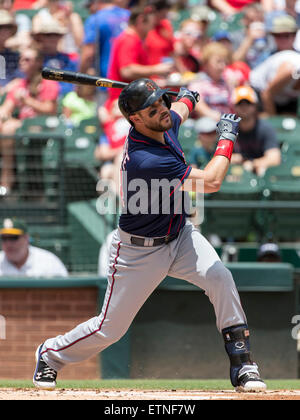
[222,324,254,387]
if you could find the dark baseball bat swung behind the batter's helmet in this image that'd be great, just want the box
[42,67,178,96]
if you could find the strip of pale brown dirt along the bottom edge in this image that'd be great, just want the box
[0,388,300,401]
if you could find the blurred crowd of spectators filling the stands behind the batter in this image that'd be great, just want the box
[0,0,300,274]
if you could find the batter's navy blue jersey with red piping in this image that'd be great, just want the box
[119,111,192,237]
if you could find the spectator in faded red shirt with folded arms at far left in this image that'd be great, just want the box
[0,48,59,195]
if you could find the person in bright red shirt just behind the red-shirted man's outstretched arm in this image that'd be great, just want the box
[145,0,174,64]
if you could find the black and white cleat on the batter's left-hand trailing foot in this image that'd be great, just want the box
[33,344,57,390]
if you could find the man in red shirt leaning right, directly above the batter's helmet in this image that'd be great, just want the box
[108,6,173,104]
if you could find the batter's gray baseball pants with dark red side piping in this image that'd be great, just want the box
[42,221,247,371]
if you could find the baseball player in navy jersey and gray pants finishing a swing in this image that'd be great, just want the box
[33,78,266,391]
